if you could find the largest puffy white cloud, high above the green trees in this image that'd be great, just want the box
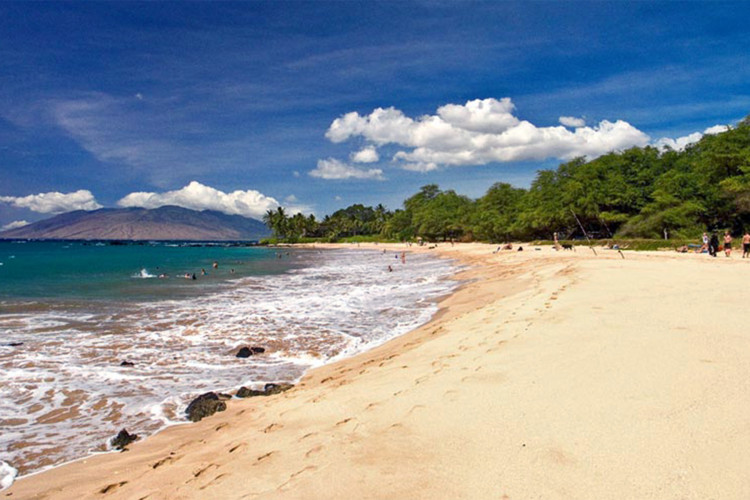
[326,98,649,172]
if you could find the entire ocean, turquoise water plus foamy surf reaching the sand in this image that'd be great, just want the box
[0,242,456,484]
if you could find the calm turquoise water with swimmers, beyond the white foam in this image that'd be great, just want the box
[0,241,297,301]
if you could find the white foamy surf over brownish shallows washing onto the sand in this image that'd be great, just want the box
[0,250,455,475]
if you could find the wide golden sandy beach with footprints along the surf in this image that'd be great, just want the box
[5,244,750,499]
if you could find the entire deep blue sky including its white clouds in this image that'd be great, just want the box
[0,0,750,228]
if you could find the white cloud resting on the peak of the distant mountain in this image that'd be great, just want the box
[117,181,279,219]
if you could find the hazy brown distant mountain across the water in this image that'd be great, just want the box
[0,206,270,241]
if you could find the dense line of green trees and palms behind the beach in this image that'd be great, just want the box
[263,116,750,242]
